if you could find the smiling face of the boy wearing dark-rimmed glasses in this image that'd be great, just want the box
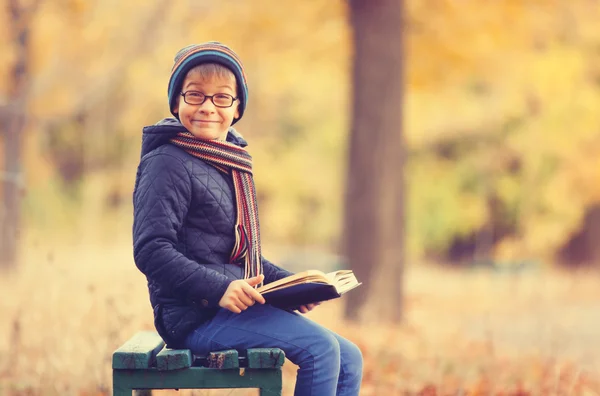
[174,70,240,140]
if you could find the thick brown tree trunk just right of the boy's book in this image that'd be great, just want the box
[345,0,405,323]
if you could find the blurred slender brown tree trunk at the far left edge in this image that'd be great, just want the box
[0,0,39,268]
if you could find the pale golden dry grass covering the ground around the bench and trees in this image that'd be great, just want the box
[0,224,600,396]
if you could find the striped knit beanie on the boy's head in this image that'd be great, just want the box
[168,41,248,125]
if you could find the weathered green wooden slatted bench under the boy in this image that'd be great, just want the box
[112,331,285,396]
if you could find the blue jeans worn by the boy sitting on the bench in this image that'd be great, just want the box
[185,304,362,396]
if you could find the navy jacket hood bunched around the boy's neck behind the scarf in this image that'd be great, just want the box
[141,117,248,157]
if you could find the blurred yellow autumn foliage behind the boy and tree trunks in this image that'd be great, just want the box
[0,0,600,264]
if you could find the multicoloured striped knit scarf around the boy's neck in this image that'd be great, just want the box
[171,131,262,287]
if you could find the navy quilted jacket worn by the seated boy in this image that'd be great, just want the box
[133,118,292,347]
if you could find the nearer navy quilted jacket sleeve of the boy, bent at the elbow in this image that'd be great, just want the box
[133,153,232,307]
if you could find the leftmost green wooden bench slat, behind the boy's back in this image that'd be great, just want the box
[113,331,165,370]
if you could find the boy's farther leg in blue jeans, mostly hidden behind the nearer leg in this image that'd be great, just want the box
[331,332,363,396]
